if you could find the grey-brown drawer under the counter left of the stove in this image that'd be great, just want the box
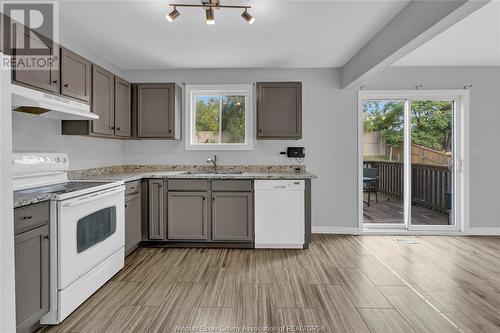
[14,201,49,235]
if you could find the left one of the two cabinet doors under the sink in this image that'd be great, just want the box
[167,192,208,241]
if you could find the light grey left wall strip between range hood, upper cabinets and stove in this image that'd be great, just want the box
[12,112,123,170]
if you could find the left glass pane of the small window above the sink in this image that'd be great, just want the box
[194,96,220,144]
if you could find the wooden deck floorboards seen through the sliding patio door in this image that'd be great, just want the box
[363,194,449,225]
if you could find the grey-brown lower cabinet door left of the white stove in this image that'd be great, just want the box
[15,225,49,332]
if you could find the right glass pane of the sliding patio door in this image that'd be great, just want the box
[410,100,454,225]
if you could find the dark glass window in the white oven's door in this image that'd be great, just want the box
[76,207,116,253]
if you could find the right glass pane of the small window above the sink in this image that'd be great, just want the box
[221,96,245,143]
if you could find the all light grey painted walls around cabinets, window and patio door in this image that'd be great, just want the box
[14,67,500,231]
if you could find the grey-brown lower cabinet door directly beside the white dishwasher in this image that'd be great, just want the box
[212,192,253,241]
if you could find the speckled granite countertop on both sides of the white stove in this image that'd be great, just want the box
[14,165,316,208]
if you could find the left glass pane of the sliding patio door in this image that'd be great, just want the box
[362,100,405,225]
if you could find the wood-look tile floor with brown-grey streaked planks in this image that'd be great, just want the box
[43,235,500,333]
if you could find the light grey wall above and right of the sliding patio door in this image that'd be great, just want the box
[366,67,500,232]
